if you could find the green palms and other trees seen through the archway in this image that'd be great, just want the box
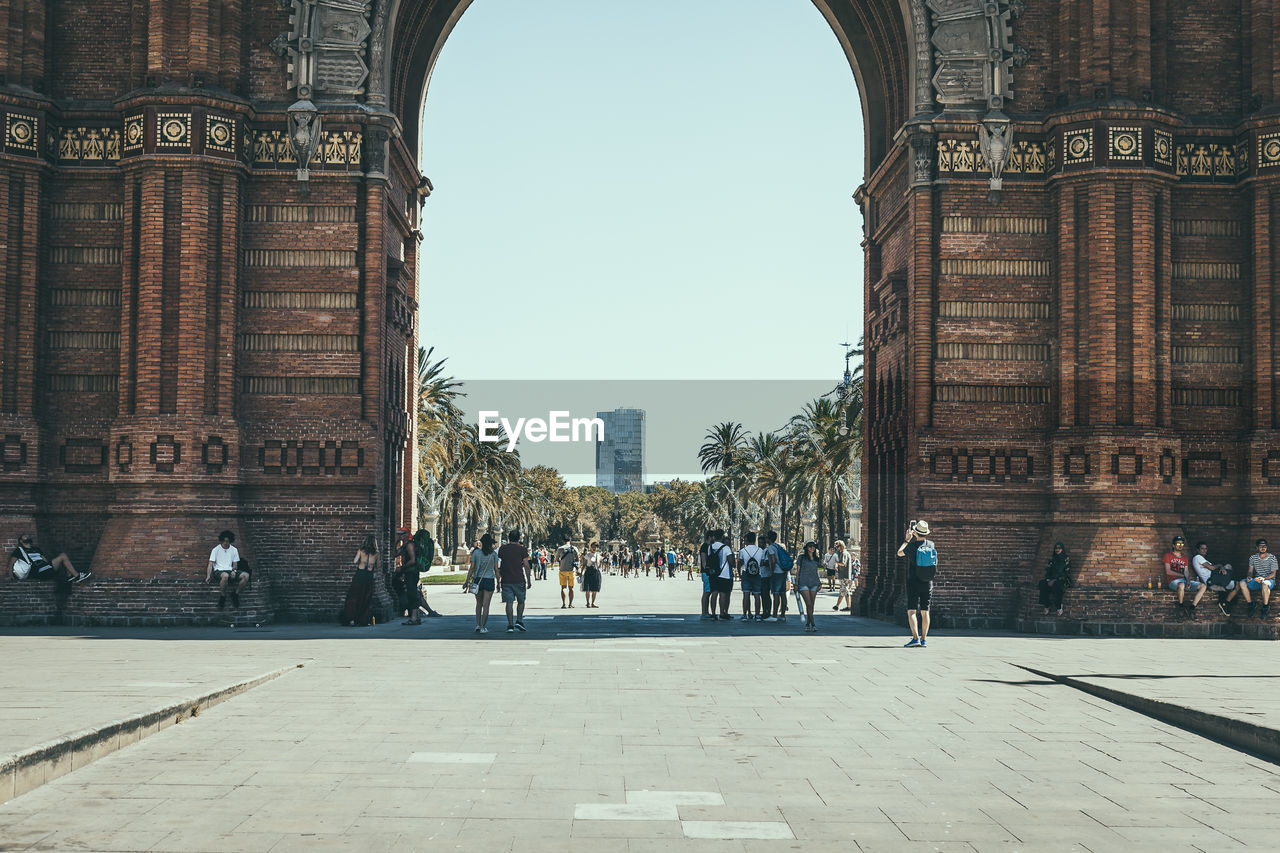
[417,348,863,553]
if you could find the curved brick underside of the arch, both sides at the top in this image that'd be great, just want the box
[387,0,928,172]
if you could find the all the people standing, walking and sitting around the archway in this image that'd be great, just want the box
[9,520,1280,630]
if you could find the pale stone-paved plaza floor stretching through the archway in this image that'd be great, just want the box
[0,578,1280,853]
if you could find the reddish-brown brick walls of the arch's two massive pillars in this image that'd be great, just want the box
[0,0,1280,633]
